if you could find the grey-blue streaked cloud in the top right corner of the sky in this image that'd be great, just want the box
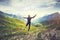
[38,0,60,9]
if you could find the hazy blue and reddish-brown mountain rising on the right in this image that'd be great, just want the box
[38,12,60,24]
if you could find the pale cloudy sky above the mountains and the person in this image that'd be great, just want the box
[0,0,60,19]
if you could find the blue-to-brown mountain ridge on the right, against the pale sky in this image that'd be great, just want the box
[38,12,60,22]
